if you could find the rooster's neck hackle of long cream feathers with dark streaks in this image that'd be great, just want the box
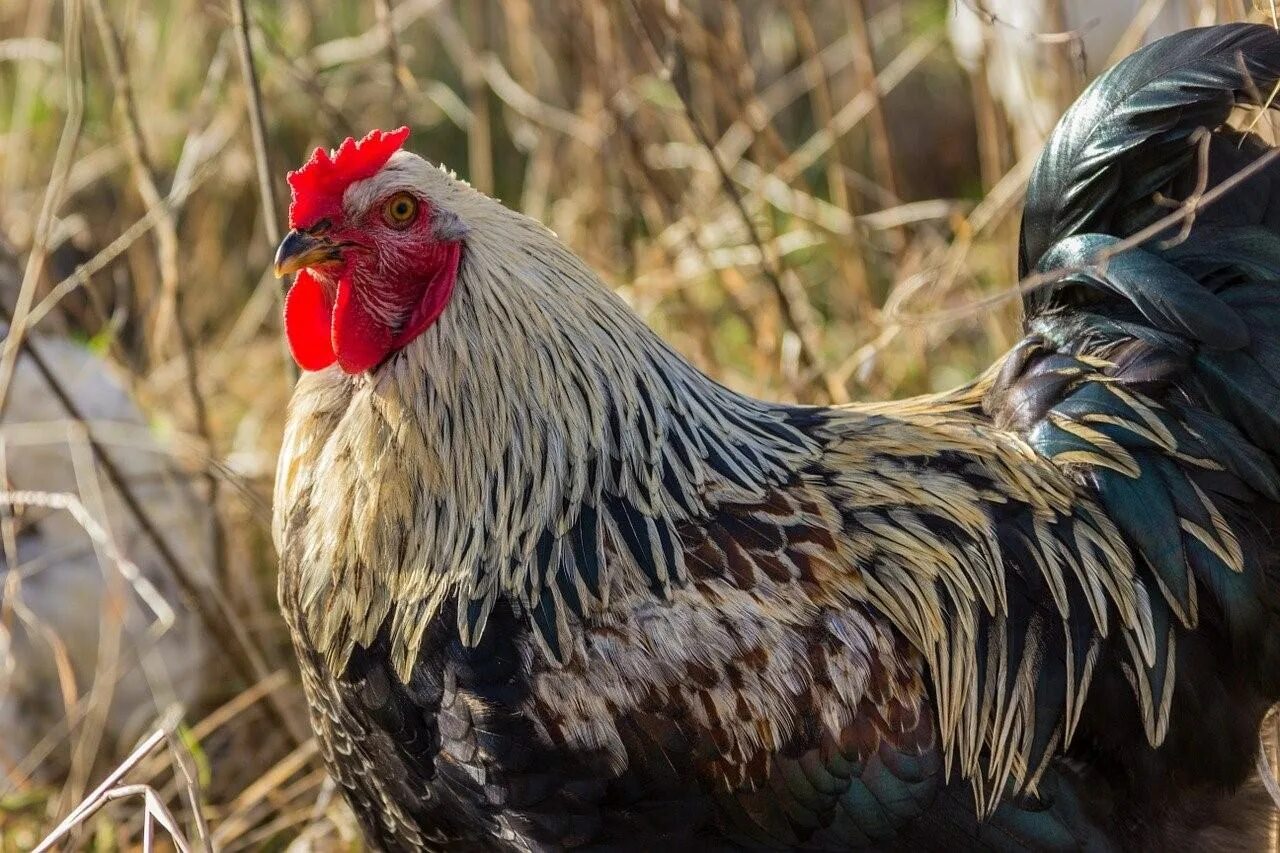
[278,205,815,676]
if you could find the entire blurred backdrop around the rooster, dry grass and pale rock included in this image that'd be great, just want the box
[0,0,1275,852]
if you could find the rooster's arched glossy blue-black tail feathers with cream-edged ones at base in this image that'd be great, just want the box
[1021,24,1280,666]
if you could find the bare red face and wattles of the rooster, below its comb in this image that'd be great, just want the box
[284,199,462,374]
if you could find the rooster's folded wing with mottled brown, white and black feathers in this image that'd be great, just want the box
[519,479,1121,850]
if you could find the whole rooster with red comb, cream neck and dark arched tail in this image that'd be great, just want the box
[273,24,1280,850]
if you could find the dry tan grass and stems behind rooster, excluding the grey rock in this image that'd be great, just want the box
[0,0,1270,852]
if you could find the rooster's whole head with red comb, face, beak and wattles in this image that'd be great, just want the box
[275,127,465,374]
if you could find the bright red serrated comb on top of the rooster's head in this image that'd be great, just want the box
[288,127,408,228]
